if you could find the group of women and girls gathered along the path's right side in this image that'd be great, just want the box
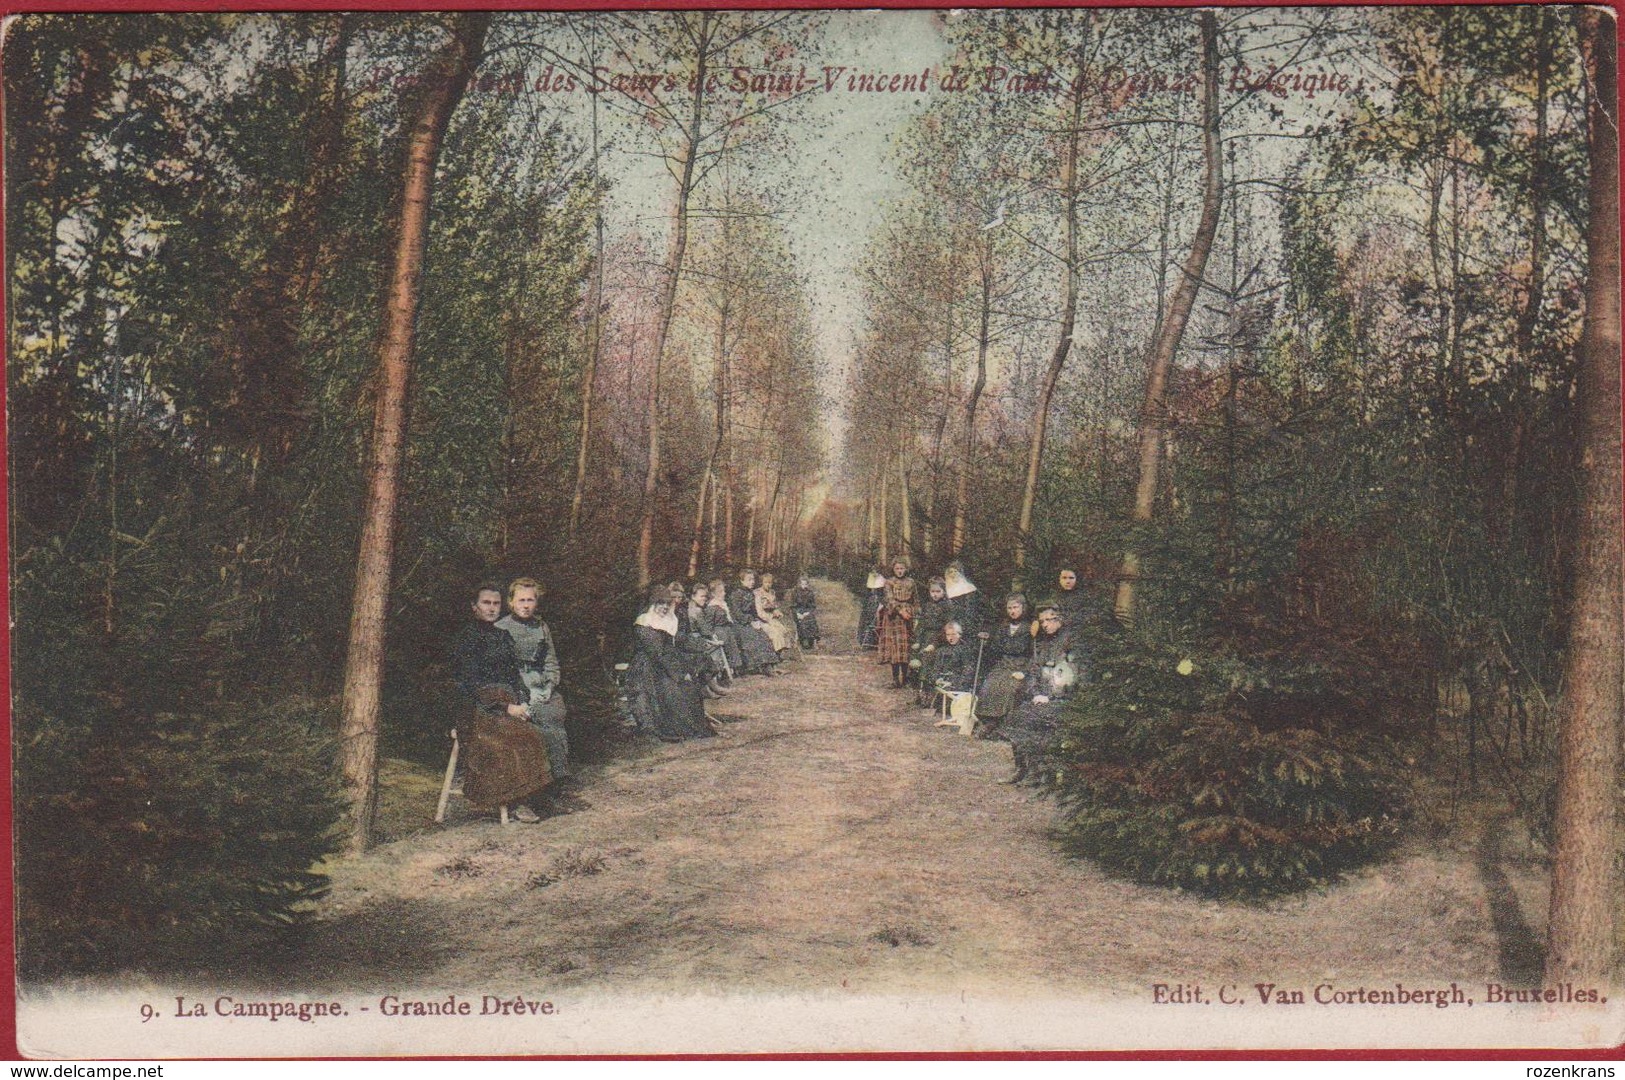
[858,560,1110,783]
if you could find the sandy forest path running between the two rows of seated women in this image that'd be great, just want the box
[273,583,1545,1000]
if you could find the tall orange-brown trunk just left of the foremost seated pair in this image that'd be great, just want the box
[340,13,491,853]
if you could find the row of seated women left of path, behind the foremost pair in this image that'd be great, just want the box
[626,570,819,742]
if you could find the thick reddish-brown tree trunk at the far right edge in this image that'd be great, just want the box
[1545,8,1625,987]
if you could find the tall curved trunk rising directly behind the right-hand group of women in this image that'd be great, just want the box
[1115,11,1224,622]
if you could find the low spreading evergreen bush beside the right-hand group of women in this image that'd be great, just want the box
[1047,626,1407,896]
